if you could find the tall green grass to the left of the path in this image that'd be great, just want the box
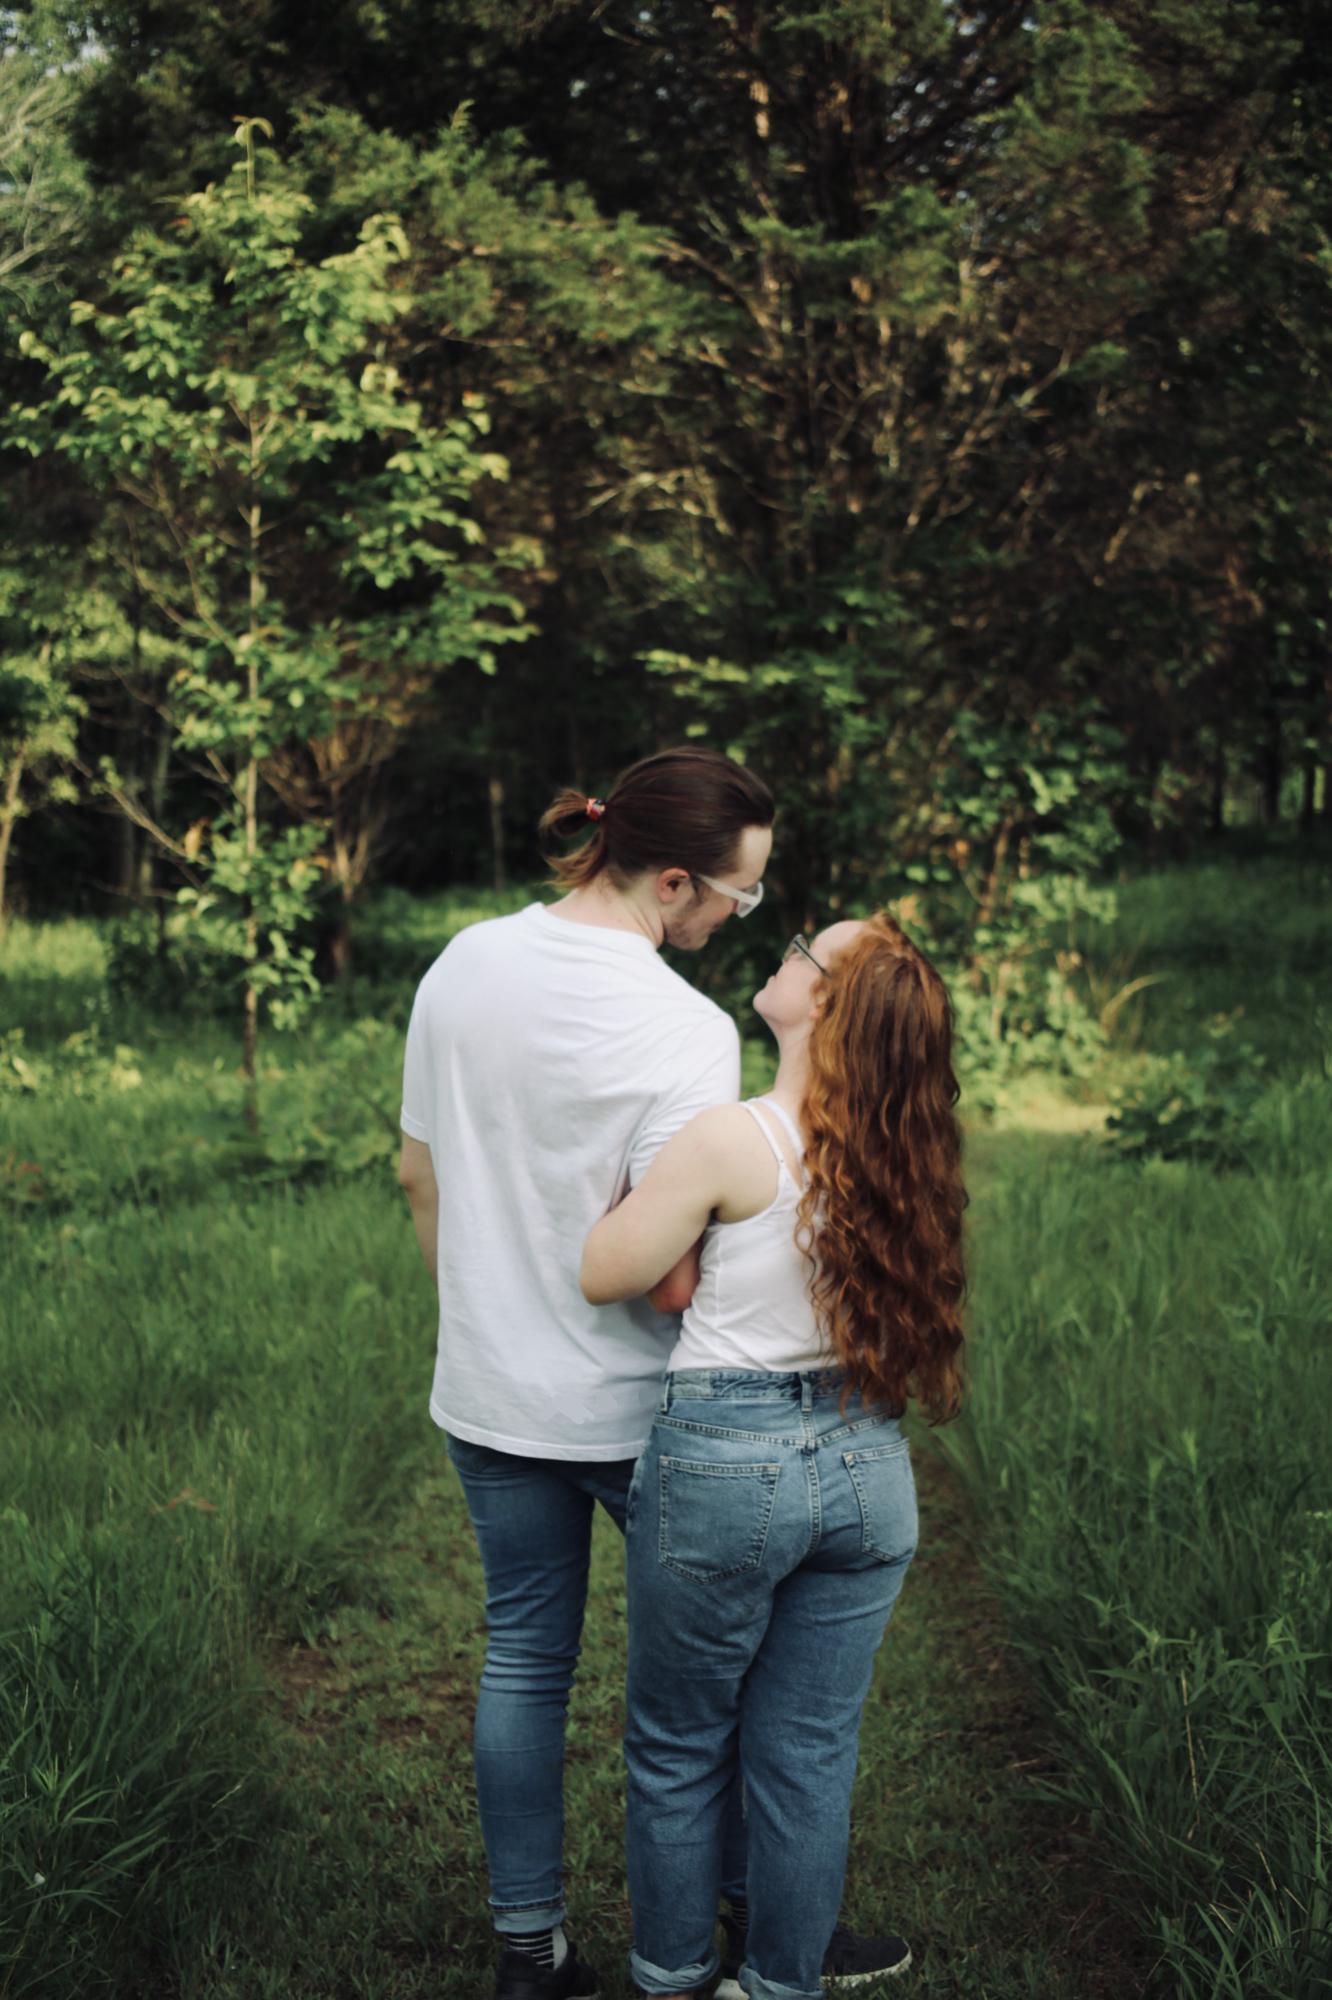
[0,1100,434,2000]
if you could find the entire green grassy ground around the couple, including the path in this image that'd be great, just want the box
[0,862,1332,2000]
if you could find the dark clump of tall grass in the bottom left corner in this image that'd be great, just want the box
[0,1514,284,2000]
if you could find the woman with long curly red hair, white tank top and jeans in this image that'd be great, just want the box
[582,914,966,2000]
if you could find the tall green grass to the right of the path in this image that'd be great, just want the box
[944,1080,1332,2000]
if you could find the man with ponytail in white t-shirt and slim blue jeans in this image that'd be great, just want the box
[398,748,774,2000]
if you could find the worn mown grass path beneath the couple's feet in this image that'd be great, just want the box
[233,1444,1150,2000]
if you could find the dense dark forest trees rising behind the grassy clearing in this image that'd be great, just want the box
[0,0,1332,968]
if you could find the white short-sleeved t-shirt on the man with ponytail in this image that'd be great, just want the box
[402,904,740,1460]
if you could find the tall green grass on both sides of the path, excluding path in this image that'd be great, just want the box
[0,862,1332,2000]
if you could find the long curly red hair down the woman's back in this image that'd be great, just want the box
[796,910,966,1424]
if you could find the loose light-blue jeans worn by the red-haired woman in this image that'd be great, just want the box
[624,1370,916,2000]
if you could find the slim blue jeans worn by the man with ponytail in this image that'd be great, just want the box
[448,1436,744,1934]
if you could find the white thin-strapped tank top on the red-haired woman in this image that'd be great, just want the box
[668,1098,834,1374]
